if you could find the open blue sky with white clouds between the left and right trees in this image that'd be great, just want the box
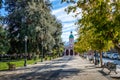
[50,0,77,42]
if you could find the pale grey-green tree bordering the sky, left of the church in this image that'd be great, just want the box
[29,1,62,58]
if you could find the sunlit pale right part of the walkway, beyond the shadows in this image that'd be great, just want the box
[61,57,120,80]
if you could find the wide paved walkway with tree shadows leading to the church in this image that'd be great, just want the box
[0,56,120,80]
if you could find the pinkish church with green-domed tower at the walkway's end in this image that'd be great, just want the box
[64,31,74,56]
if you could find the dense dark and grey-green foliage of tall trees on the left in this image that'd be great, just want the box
[4,0,62,58]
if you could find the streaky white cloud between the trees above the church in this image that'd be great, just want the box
[51,0,81,42]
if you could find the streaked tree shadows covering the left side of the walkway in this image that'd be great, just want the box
[0,57,83,80]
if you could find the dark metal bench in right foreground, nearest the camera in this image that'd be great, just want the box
[102,62,117,74]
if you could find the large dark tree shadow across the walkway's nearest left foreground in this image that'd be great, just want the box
[0,68,83,80]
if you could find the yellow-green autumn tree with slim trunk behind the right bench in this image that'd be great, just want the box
[63,0,120,65]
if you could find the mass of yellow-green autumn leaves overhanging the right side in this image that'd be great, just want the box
[65,0,120,51]
